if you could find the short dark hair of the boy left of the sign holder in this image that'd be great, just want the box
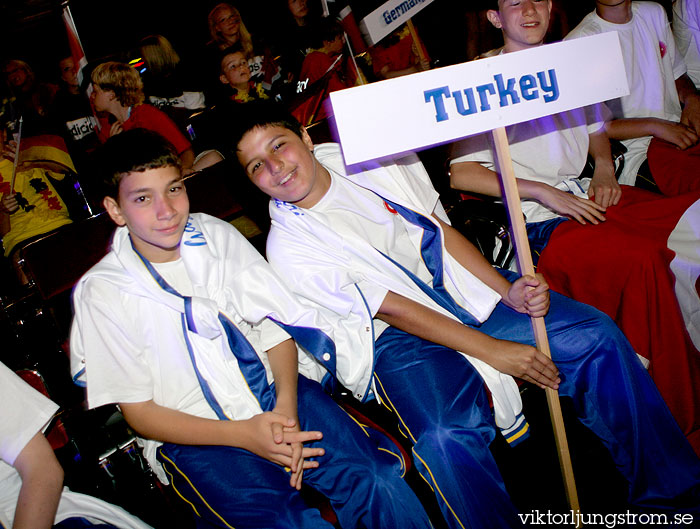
[96,128,181,200]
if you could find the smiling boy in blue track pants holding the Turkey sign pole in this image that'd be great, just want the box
[231,101,700,528]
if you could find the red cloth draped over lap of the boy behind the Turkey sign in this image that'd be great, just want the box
[538,186,700,454]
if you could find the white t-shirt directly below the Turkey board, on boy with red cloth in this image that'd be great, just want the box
[450,107,604,222]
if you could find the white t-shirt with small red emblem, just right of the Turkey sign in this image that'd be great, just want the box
[566,1,686,185]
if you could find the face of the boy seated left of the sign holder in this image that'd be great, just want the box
[104,166,190,263]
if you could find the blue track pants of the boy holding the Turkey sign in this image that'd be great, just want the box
[375,286,700,528]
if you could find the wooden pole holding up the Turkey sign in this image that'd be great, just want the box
[492,127,580,512]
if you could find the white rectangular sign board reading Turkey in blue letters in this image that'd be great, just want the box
[330,32,629,165]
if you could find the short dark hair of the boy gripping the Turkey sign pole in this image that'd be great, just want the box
[225,101,303,156]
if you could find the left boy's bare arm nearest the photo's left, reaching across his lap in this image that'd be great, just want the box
[119,400,324,468]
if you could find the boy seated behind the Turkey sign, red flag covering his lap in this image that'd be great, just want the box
[451,1,700,453]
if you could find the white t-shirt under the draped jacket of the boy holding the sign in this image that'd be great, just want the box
[311,171,433,337]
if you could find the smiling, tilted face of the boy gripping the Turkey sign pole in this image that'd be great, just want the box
[238,125,330,208]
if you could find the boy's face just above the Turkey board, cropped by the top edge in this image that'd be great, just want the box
[486,0,552,52]
